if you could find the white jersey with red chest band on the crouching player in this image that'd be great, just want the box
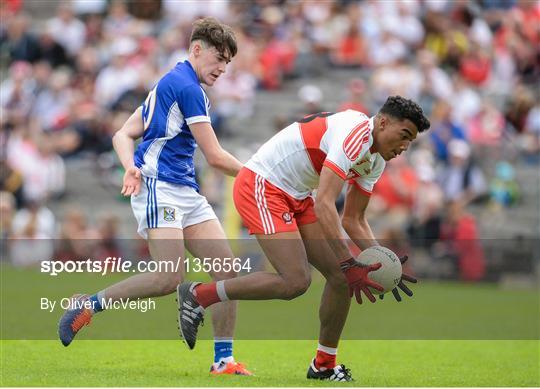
[246,110,386,200]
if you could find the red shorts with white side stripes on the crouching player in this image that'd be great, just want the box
[233,167,317,235]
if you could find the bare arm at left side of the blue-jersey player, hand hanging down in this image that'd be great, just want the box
[112,107,144,196]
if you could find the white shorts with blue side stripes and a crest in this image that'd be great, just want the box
[131,176,217,239]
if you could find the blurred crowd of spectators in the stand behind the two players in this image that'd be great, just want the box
[0,0,540,280]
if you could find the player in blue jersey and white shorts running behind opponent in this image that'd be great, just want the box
[59,18,251,375]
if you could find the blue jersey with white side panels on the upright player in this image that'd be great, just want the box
[135,61,210,191]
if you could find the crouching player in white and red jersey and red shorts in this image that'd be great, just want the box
[179,96,430,381]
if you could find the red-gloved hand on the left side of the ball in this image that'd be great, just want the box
[339,258,384,304]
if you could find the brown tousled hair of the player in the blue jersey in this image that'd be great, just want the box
[190,17,238,59]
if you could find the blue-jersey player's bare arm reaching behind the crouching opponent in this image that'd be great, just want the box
[189,122,243,177]
